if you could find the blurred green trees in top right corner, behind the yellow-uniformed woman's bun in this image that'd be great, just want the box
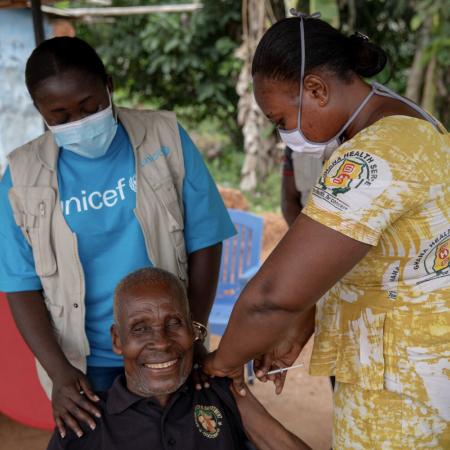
[336,0,450,126]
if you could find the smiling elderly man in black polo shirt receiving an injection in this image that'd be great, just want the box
[48,268,309,450]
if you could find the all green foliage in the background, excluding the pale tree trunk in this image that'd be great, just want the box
[68,0,450,211]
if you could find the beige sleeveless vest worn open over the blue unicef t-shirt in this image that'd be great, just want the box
[8,108,188,398]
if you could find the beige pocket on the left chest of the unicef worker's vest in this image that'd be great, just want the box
[9,186,57,277]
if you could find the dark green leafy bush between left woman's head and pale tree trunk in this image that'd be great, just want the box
[77,0,241,135]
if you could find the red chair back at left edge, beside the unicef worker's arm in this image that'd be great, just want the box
[0,293,55,430]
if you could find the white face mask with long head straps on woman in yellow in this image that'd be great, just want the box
[278,10,374,158]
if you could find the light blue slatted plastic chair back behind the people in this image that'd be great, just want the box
[216,209,264,301]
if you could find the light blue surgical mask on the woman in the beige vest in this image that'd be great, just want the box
[46,90,117,159]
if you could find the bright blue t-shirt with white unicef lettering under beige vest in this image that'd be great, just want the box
[0,125,235,366]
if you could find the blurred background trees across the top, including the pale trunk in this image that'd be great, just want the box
[71,0,450,190]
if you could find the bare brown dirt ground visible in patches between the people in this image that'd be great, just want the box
[0,205,332,450]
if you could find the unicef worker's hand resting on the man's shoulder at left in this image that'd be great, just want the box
[52,365,101,438]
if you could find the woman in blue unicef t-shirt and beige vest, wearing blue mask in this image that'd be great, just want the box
[0,37,234,435]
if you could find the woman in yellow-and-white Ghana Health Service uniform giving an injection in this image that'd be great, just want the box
[206,13,450,450]
